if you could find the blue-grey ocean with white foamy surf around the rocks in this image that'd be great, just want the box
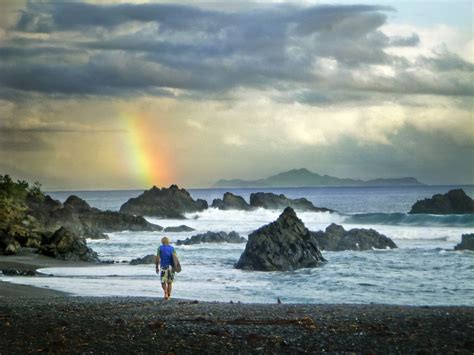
[0,185,474,306]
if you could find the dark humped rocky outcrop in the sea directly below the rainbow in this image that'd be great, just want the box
[120,185,208,219]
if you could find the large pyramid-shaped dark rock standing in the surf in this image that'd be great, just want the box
[236,207,325,271]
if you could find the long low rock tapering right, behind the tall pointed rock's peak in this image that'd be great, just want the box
[250,192,334,212]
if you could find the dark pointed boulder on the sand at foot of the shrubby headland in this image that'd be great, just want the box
[38,227,99,262]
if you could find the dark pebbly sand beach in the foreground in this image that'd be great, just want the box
[0,255,474,354]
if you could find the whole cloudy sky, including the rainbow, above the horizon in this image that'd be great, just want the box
[0,0,474,190]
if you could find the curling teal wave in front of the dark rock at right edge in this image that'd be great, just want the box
[344,213,474,227]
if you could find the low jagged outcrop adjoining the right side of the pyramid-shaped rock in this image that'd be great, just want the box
[311,223,397,251]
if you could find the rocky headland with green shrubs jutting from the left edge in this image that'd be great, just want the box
[0,175,162,260]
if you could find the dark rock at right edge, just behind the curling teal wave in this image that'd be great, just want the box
[409,189,474,214]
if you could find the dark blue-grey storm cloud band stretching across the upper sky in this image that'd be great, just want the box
[0,2,473,103]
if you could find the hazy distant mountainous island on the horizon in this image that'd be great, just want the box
[214,169,423,187]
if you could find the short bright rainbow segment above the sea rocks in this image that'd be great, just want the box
[122,113,172,188]
